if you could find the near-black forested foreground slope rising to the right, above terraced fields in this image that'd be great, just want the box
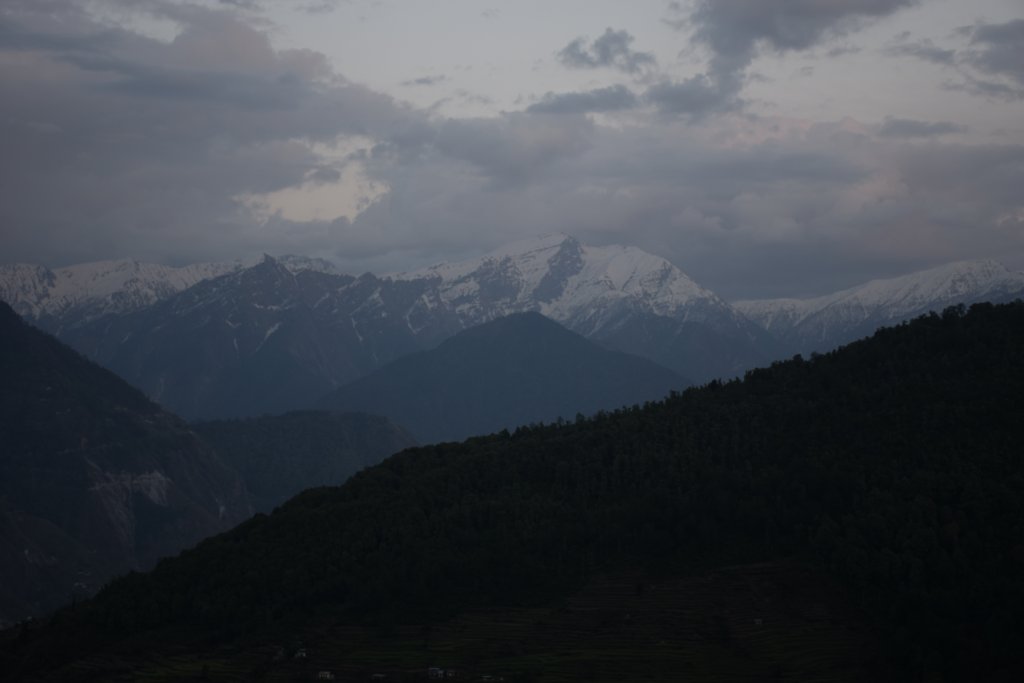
[9,301,1024,680]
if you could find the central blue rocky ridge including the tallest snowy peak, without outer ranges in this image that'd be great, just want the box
[9,236,771,419]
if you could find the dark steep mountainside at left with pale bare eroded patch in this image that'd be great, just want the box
[0,302,251,623]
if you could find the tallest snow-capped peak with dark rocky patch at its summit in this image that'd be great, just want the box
[396,234,775,382]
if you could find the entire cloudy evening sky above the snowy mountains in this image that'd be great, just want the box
[0,0,1024,298]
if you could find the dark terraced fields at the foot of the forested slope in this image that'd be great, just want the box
[0,562,887,683]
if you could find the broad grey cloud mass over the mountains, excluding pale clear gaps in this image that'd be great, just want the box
[0,0,1024,297]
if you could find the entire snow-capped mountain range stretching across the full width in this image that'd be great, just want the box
[0,234,1024,419]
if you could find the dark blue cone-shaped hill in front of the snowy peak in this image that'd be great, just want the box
[321,313,689,442]
